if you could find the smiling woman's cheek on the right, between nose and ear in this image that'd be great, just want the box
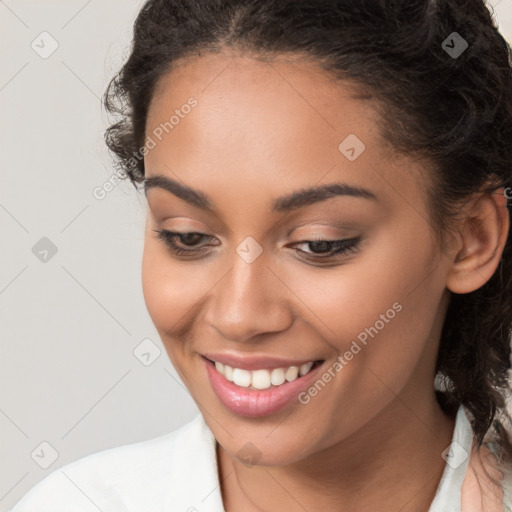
[287,227,444,389]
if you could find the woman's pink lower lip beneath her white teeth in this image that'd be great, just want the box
[204,359,323,418]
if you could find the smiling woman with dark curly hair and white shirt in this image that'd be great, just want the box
[14,0,512,512]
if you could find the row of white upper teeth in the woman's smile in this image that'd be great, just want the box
[211,361,313,390]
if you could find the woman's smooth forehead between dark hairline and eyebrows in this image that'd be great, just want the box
[145,53,432,220]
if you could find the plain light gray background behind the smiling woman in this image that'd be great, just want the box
[0,0,512,511]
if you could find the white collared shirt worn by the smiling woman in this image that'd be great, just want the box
[11,407,510,512]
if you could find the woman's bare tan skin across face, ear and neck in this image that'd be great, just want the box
[142,51,508,512]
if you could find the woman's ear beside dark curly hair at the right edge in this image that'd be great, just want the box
[446,188,510,293]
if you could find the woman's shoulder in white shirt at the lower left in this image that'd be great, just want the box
[11,415,222,512]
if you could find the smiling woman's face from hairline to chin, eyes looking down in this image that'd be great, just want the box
[142,50,447,465]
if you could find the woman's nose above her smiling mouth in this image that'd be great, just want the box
[205,252,292,342]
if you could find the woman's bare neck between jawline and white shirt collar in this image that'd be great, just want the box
[218,391,455,512]
